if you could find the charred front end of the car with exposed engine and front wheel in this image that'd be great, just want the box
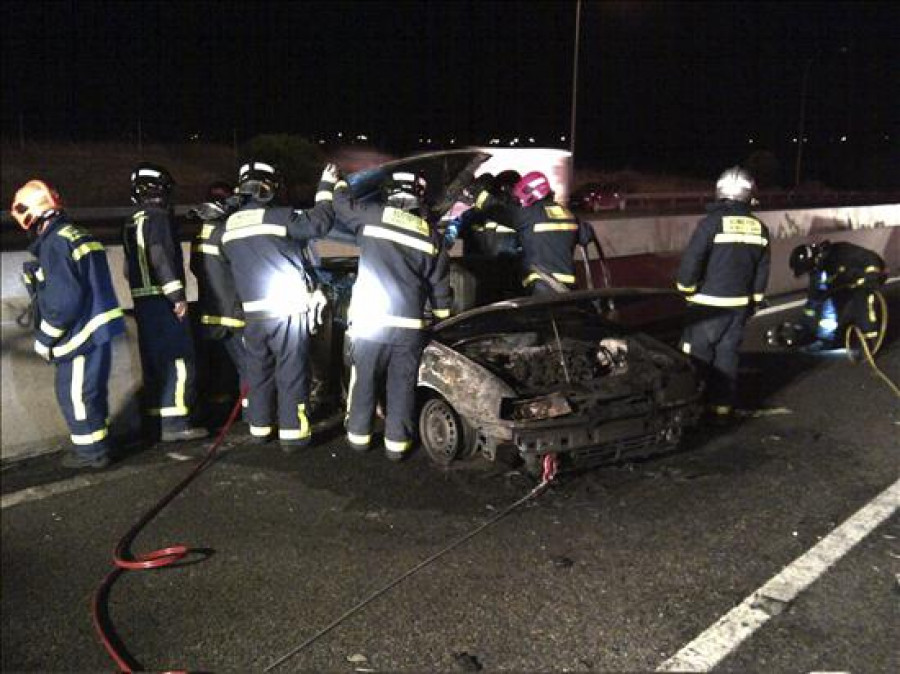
[419,290,702,473]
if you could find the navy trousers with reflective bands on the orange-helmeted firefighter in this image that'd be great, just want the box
[56,342,112,460]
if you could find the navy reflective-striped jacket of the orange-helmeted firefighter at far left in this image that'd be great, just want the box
[29,212,125,360]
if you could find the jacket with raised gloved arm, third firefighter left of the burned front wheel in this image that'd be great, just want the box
[220,182,334,320]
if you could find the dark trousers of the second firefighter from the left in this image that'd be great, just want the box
[134,297,197,431]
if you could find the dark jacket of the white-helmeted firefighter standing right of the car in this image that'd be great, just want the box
[676,200,770,308]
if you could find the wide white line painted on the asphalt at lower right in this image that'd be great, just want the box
[656,480,900,672]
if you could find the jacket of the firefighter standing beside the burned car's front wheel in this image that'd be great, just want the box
[334,182,452,344]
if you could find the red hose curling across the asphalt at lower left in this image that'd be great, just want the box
[91,390,246,674]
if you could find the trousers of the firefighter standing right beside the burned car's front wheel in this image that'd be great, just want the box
[347,338,424,453]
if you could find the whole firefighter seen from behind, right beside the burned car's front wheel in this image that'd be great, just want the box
[334,172,452,461]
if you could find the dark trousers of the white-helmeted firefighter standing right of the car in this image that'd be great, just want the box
[681,306,750,411]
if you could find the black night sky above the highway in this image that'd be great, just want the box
[2,0,900,184]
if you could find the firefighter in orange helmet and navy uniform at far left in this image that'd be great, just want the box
[11,180,125,469]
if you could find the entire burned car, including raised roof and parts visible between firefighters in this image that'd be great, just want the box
[314,151,703,474]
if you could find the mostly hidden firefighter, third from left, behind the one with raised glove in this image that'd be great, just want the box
[190,182,248,418]
